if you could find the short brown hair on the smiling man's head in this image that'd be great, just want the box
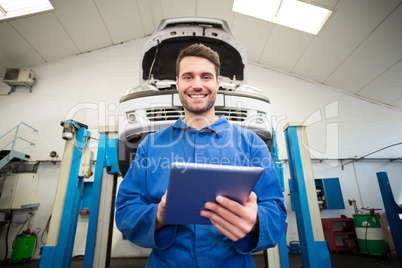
[176,44,221,79]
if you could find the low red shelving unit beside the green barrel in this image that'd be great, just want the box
[321,218,358,252]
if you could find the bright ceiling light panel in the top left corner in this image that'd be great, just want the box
[0,0,53,20]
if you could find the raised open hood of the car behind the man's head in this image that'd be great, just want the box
[140,17,247,89]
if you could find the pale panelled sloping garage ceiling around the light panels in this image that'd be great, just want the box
[0,0,402,111]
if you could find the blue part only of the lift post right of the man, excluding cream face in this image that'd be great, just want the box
[285,126,332,268]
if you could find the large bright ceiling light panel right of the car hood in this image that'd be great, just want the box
[233,0,332,34]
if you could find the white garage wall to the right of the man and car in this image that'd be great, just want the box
[248,64,402,248]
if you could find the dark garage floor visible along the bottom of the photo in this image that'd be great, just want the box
[0,253,402,268]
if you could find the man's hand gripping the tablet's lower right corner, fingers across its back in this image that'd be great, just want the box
[200,192,258,241]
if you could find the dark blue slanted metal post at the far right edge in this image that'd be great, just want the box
[377,172,402,259]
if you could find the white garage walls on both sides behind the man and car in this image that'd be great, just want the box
[0,38,402,258]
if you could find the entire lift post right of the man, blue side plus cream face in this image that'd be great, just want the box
[284,124,332,268]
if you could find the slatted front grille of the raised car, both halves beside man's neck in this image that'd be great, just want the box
[145,107,247,122]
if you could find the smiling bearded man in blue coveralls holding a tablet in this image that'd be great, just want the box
[116,44,286,268]
